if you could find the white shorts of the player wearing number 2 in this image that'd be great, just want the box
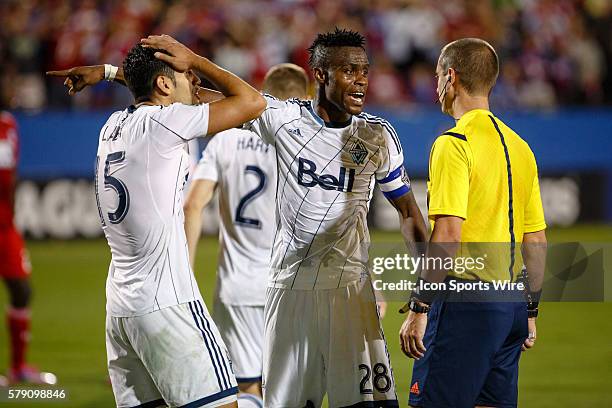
[213,300,264,383]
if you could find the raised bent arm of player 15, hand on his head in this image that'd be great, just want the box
[142,35,266,135]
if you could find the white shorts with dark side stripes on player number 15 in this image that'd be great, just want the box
[106,301,238,407]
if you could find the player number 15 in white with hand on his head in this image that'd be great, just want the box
[95,36,265,407]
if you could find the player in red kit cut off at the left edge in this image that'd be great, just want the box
[0,110,56,386]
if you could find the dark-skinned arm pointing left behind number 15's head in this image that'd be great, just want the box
[47,65,224,103]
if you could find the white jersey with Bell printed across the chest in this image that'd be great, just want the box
[247,97,410,290]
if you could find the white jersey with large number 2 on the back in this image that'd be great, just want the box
[193,129,276,306]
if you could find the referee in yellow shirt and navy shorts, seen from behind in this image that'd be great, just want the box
[400,38,546,408]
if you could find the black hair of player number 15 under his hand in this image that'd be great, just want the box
[123,44,174,102]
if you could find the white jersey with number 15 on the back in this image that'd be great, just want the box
[95,103,208,317]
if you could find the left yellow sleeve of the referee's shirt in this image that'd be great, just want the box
[428,136,470,219]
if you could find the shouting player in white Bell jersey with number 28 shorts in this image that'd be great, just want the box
[241,29,426,408]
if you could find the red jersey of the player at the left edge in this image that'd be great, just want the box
[0,112,19,229]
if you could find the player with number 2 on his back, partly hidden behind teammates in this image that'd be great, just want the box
[180,64,308,407]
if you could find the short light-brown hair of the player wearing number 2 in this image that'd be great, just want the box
[263,63,308,100]
